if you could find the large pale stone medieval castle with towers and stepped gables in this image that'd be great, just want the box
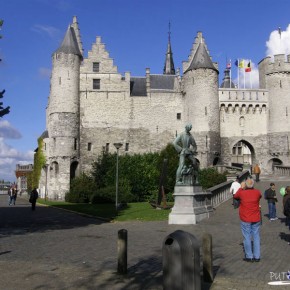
[39,17,290,199]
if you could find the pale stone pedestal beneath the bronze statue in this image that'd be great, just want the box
[168,185,212,225]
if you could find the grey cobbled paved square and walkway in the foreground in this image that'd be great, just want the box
[0,173,290,290]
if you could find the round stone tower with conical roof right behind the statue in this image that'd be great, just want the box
[182,32,220,167]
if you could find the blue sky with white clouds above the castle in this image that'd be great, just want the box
[0,0,290,181]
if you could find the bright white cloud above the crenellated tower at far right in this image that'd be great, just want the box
[266,24,290,56]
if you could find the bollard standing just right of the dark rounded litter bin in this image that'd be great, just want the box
[202,233,213,283]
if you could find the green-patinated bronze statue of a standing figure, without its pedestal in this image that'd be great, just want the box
[173,123,198,185]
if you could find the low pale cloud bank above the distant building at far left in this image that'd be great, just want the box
[0,138,34,181]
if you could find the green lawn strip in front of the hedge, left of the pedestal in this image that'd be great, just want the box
[37,199,170,222]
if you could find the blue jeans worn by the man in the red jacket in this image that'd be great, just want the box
[241,221,261,259]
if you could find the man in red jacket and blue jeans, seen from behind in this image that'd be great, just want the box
[234,178,262,262]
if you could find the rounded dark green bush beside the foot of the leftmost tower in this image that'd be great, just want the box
[65,173,97,203]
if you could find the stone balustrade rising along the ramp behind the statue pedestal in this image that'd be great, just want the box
[207,170,250,208]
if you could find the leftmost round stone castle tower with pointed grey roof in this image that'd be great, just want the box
[45,17,82,199]
